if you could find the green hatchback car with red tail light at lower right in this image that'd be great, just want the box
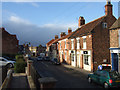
[88,70,120,88]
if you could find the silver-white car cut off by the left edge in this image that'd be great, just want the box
[0,57,15,68]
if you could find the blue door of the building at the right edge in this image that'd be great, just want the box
[112,53,118,71]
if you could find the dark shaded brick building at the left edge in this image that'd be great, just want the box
[0,28,19,54]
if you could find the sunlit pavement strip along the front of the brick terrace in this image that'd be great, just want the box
[62,63,92,75]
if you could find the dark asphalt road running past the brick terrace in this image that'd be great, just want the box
[33,61,102,88]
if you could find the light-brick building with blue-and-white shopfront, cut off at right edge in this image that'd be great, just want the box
[110,17,120,72]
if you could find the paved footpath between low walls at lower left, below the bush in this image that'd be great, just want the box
[10,73,30,90]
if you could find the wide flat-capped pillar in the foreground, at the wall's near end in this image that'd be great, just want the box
[38,77,57,90]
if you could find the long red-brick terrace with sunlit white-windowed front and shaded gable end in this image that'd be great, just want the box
[46,1,116,71]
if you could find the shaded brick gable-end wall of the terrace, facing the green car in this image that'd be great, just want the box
[93,16,116,70]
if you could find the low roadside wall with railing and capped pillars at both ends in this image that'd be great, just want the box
[27,60,57,90]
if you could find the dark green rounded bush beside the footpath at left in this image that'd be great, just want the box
[14,59,27,73]
